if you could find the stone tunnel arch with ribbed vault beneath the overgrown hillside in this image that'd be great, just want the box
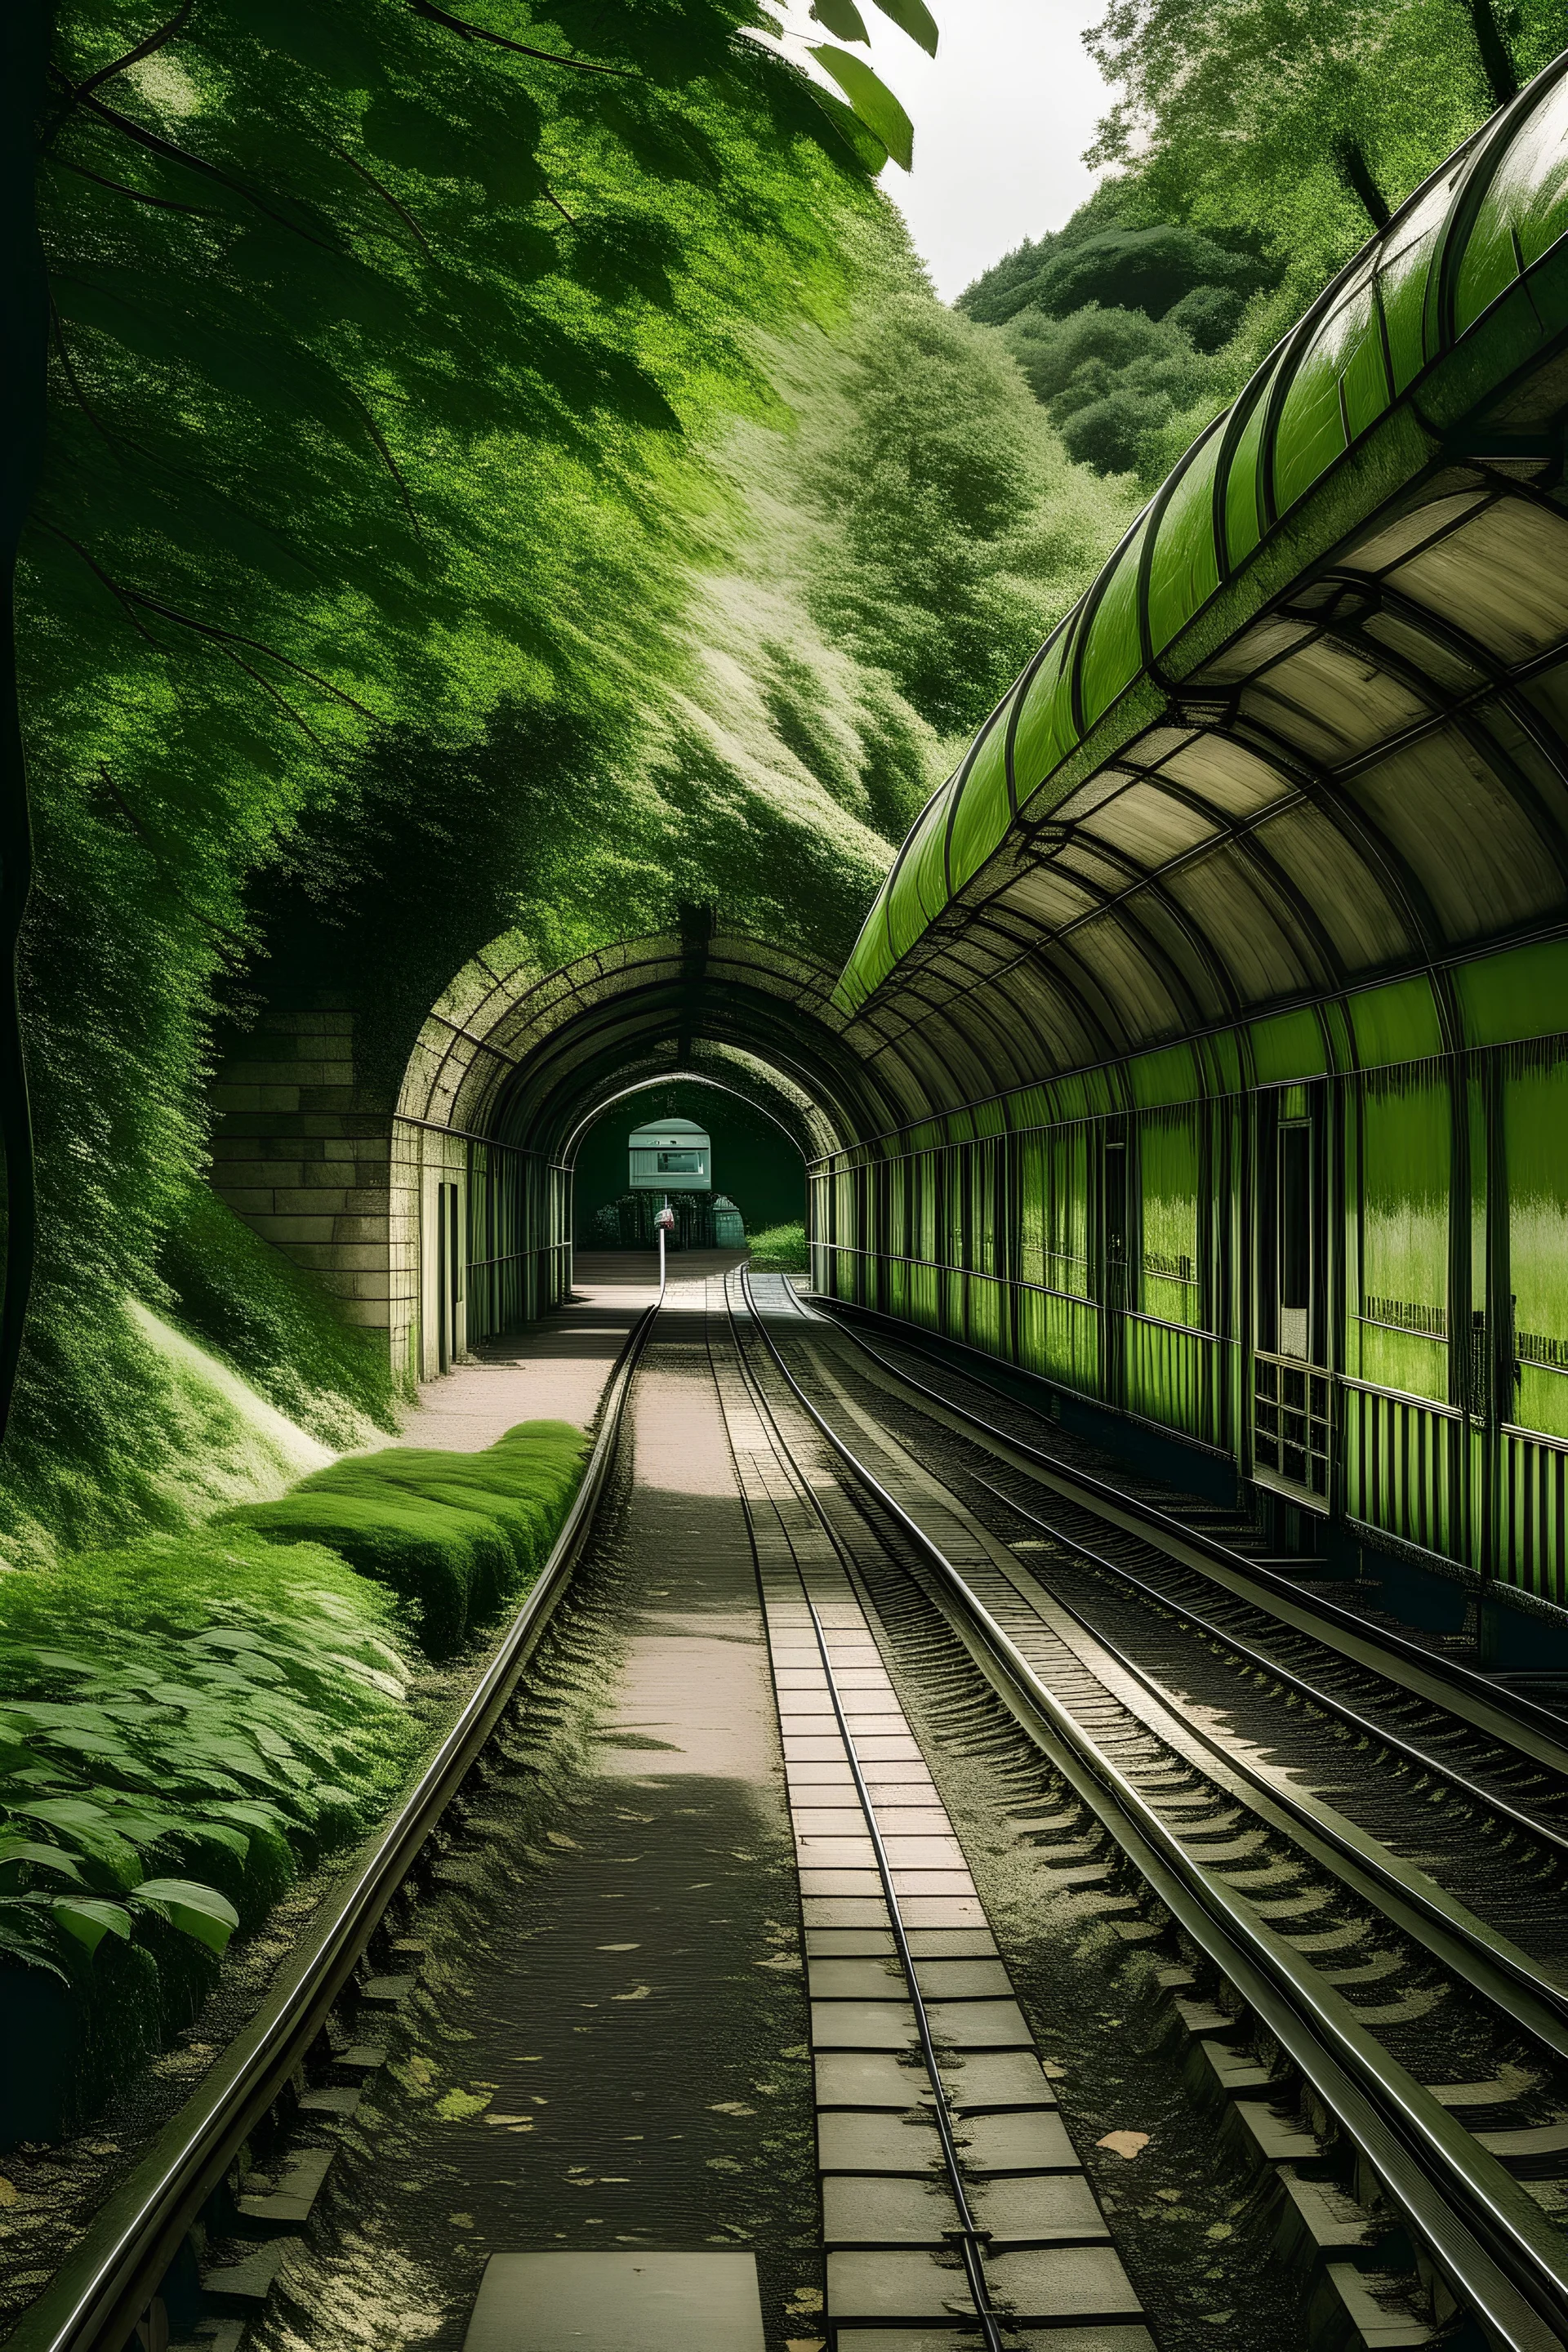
[388,911,933,1379]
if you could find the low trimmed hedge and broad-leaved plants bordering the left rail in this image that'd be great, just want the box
[0,1421,586,2147]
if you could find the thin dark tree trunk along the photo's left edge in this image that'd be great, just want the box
[0,0,54,1440]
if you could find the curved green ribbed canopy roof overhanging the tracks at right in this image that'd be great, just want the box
[832,56,1568,1072]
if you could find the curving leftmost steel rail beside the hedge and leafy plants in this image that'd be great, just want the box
[5,1291,663,2352]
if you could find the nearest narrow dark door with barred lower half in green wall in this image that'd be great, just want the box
[1253,1085,1333,1510]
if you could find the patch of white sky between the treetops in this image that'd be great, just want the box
[766,0,1110,301]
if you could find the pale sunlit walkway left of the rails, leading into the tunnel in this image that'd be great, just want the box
[402,1249,741,1454]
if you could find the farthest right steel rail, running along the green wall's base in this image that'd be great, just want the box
[817,1301,1568,1768]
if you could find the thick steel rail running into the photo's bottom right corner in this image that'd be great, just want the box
[743,1272,1568,2352]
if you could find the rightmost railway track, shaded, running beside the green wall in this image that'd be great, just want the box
[799,1334,1568,2003]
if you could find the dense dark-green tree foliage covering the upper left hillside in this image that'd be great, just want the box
[7,0,867,1543]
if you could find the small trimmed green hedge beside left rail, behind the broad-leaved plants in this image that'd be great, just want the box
[228,1421,586,1656]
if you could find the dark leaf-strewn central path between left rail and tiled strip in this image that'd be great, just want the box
[390,1254,821,2352]
